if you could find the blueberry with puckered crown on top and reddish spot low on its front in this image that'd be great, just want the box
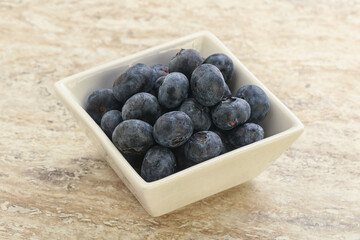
[211,97,251,130]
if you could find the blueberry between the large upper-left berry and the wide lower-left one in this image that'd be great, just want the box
[122,92,161,125]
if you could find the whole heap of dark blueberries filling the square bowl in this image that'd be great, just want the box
[86,49,270,182]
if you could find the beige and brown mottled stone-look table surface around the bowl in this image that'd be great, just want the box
[0,0,360,240]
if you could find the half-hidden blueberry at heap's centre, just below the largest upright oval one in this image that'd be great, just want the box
[179,98,211,131]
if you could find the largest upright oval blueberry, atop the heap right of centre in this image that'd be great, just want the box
[190,64,225,107]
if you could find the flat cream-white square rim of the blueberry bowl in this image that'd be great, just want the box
[54,31,304,191]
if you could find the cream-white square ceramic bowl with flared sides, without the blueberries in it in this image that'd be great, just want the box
[55,31,304,217]
